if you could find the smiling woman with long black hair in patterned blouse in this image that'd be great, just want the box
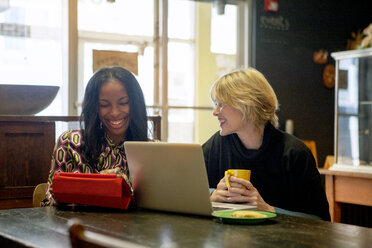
[42,67,149,206]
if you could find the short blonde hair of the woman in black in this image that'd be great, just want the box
[211,68,279,128]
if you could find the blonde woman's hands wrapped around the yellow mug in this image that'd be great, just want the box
[211,176,275,212]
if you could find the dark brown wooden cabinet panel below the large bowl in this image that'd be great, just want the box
[0,122,55,209]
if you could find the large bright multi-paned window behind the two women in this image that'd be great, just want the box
[0,0,247,143]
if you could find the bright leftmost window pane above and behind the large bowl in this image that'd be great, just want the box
[0,0,63,115]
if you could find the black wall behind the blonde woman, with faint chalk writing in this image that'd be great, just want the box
[252,0,372,167]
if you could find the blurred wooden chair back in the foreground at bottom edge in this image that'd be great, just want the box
[67,219,147,248]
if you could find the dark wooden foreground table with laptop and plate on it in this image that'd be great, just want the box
[0,207,372,248]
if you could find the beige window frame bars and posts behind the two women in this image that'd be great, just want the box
[68,0,252,141]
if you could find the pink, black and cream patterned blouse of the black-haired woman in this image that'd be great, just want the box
[41,130,133,206]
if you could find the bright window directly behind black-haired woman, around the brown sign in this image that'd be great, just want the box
[78,0,154,110]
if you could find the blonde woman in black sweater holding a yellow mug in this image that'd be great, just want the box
[203,68,330,220]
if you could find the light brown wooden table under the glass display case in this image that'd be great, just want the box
[319,169,372,222]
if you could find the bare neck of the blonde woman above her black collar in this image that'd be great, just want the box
[237,124,264,150]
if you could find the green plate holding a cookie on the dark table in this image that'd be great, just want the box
[212,210,276,224]
